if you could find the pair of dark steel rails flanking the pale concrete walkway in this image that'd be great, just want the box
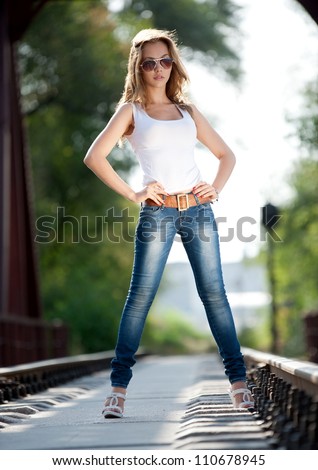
[0,348,318,450]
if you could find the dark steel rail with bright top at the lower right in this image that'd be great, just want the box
[243,348,318,450]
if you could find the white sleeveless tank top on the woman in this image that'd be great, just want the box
[127,103,201,194]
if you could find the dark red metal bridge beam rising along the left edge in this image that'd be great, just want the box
[0,0,46,365]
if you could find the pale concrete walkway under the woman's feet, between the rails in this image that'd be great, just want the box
[0,354,270,450]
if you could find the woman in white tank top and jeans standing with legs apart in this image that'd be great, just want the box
[84,29,253,418]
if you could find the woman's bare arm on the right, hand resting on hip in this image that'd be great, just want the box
[192,106,236,198]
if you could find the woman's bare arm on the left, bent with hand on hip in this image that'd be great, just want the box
[84,103,166,204]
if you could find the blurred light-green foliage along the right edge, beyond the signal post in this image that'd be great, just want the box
[266,81,318,356]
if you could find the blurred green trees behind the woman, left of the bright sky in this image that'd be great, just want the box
[17,0,243,353]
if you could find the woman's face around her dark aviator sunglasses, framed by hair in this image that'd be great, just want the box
[141,41,172,88]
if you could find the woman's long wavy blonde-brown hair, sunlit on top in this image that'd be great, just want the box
[118,28,191,112]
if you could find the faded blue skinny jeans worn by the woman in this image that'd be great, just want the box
[111,203,246,388]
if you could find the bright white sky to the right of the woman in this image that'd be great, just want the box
[129,0,318,263]
